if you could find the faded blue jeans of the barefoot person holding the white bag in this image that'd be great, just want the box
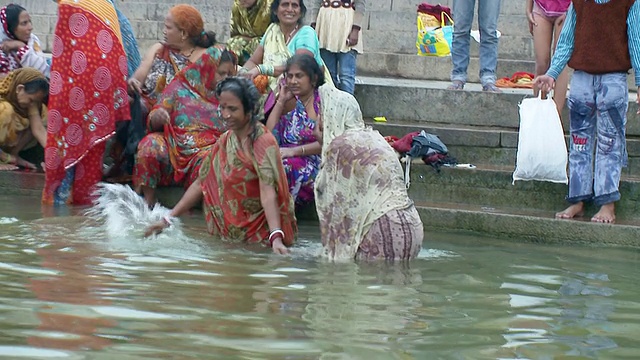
[567,71,629,206]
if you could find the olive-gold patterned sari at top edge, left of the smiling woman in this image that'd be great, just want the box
[227,0,272,65]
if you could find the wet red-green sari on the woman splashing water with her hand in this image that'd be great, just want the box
[200,123,297,246]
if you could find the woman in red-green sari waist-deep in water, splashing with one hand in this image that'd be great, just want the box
[147,77,297,254]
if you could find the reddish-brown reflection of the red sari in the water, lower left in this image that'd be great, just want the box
[27,218,117,350]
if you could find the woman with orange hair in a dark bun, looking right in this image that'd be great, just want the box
[127,4,216,113]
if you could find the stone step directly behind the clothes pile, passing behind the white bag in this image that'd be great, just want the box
[365,119,640,175]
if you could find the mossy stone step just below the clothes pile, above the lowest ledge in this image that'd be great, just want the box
[409,161,640,221]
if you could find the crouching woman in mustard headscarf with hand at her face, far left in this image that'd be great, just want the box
[0,68,49,170]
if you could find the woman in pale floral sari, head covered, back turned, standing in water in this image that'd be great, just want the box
[315,85,424,260]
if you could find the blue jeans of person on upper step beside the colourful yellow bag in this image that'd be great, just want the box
[451,0,500,85]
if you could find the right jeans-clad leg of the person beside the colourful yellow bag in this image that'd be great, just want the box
[478,0,501,92]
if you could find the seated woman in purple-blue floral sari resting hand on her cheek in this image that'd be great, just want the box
[267,54,324,205]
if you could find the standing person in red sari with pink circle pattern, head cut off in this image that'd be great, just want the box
[42,0,130,205]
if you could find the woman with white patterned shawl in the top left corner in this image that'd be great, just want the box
[0,4,51,77]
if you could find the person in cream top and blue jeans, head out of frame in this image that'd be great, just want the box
[312,0,365,94]
